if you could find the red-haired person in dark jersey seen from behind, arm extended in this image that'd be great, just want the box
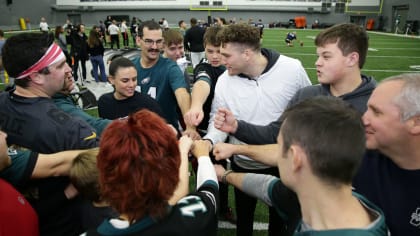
[87,110,218,235]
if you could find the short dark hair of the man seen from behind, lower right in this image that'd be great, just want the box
[279,96,366,185]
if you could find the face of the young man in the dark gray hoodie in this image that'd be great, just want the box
[315,43,351,84]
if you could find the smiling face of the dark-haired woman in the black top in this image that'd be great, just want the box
[109,67,137,100]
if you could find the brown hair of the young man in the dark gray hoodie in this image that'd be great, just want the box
[315,23,369,69]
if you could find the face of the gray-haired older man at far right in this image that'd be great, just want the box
[363,81,409,153]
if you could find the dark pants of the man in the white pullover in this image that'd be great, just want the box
[232,161,286,236]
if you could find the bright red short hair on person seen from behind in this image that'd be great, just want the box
[97,110,181,223]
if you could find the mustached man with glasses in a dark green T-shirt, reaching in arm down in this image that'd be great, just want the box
[133,21,199,137]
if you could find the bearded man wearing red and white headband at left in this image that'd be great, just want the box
[0,33,98,235]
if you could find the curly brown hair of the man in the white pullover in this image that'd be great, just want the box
[217,23,261,50]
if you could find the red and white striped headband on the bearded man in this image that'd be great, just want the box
[16,43,66,79]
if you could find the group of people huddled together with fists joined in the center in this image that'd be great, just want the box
[0,18,420,236]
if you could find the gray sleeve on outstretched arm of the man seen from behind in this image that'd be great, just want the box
[242,173,279,206]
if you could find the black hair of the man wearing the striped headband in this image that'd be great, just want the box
[2,32,54,83]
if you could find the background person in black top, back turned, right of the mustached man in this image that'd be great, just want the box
[184,17,205,68]
